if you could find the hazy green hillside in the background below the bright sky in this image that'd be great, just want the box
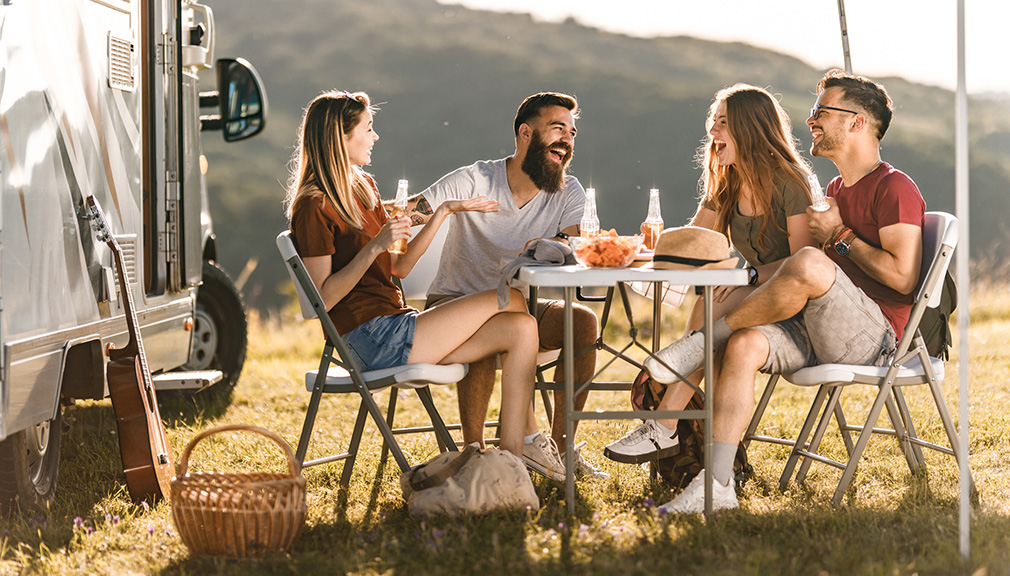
[198,0,1010,307]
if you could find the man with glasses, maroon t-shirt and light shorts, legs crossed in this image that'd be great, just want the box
[645,70,925,512]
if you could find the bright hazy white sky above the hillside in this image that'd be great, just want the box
[438,0,1010,93]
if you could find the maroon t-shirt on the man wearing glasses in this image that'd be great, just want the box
[826,162,926,340]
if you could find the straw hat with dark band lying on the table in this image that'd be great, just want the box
[652,226,737,270]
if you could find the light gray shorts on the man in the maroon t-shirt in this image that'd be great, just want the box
[753,265,897,374]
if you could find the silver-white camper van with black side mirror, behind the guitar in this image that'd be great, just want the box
[0,0,267,511]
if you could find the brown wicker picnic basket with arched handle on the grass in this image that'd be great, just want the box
[172,424,305,557]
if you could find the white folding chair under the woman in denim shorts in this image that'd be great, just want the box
[277,230,467,486]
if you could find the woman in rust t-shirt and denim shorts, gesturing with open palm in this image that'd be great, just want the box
[285,91,538,457]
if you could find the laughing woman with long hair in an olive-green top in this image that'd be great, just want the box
[604,84,814,478]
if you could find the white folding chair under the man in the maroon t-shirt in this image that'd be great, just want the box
[763,212,963,504]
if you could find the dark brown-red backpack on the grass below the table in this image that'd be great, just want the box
[631,370,753,488]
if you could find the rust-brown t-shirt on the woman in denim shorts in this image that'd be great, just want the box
[291,178,413,335]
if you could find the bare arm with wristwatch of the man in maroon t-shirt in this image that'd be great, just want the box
[807,198,922,294]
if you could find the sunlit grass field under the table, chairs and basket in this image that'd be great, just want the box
[0,288,1010,576]
